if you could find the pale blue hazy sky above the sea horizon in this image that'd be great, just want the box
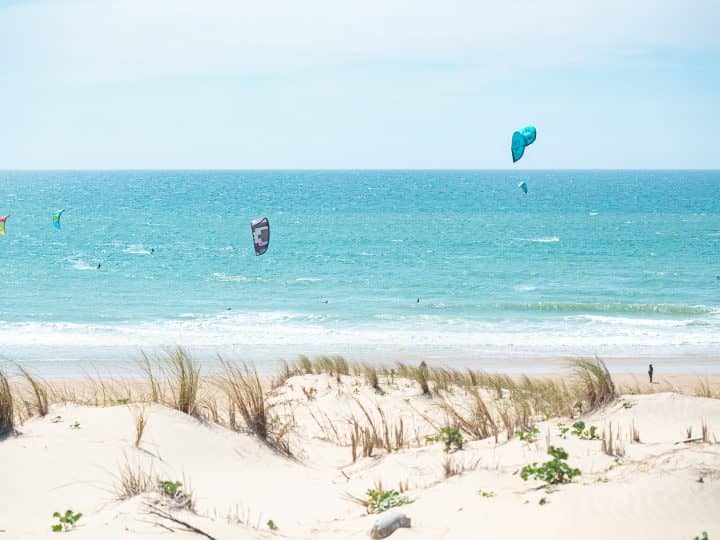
[0,0,720,169]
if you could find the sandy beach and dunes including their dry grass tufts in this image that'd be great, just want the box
[0,359,720,539]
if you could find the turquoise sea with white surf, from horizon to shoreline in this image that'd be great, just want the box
[0,171,720,372]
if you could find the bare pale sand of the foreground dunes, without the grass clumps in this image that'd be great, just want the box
[0,364,720,540]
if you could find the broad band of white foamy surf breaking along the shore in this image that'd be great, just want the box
[0,312,720,360]
